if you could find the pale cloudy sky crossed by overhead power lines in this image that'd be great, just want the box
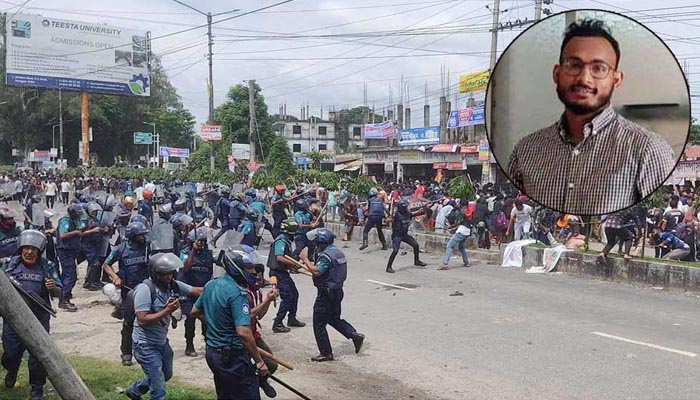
[0,0,700,126]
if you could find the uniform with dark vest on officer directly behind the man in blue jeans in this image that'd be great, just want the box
[105,242,148,356]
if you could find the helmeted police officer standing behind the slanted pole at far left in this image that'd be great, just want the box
[2,230,61,399]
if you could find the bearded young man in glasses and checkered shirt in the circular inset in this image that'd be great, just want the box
[508,20,675,215]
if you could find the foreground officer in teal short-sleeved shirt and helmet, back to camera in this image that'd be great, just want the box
[192,246,269,400]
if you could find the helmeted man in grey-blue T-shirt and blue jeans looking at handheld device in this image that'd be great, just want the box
[124,253,202,400]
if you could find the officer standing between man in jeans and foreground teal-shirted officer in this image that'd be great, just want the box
[180,228,214,357]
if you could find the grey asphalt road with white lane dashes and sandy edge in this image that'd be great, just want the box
[5,202,700,400]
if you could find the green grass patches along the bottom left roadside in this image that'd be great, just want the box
[0,353,216,400]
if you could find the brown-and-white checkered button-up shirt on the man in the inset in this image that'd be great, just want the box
[508,105,676,215]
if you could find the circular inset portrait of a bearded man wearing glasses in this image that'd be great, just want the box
[486,10,690,215]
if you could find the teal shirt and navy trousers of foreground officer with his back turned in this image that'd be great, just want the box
[195,274,260,400]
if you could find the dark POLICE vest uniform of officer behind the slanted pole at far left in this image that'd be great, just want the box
[2,255,61,398]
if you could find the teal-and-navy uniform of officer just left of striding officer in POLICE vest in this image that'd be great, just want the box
[267,233,306,326]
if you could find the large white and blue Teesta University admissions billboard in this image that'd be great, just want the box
[5,14,151,96]
